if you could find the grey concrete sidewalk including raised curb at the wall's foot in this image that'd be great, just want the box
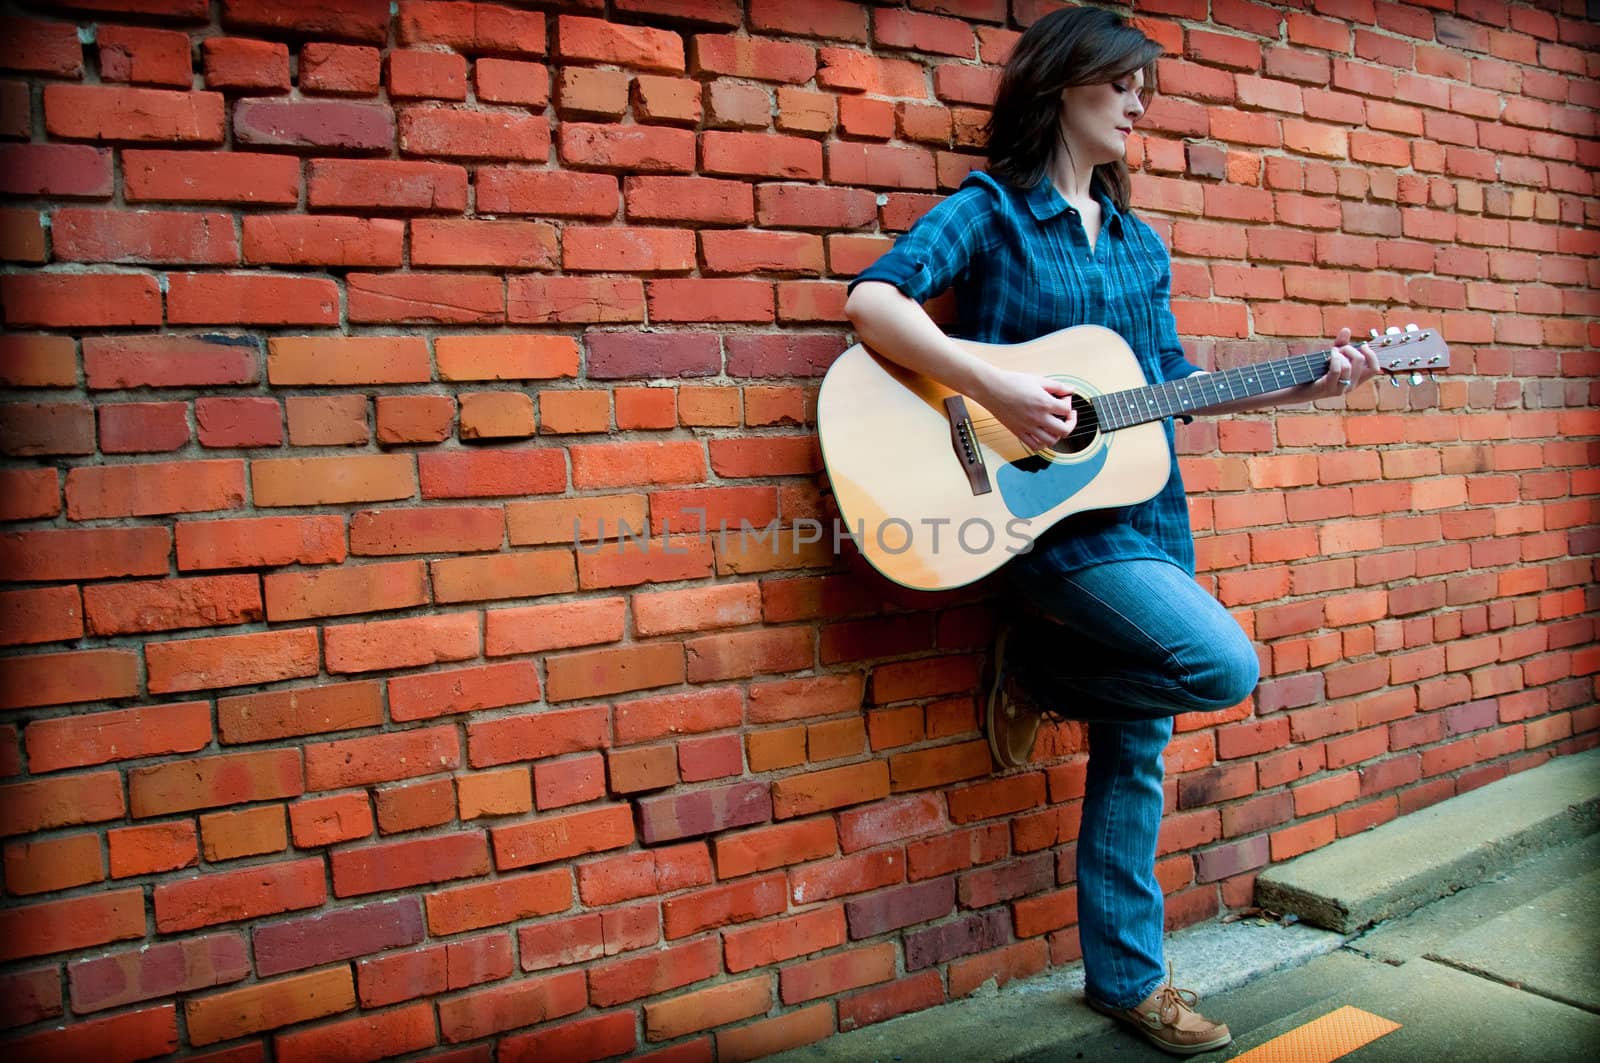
[770,749,1600,1063]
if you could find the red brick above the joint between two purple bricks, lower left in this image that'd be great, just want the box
[154,858,328,933]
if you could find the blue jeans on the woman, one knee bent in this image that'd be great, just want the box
[1006,551,1259,1009]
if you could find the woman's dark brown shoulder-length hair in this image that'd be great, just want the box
[986,8,1162,210]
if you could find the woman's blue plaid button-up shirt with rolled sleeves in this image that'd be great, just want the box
[851,173,1200,575]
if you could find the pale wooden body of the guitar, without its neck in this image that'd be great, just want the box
[818,325,1171,591]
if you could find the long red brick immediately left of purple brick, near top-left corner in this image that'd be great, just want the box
[43,85,222,144]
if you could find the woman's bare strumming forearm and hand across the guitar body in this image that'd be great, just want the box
[845,280,1077,450]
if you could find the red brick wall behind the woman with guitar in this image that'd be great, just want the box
[0,0,1600,1060]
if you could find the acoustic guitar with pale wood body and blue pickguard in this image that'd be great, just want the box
[818,325,1450,591]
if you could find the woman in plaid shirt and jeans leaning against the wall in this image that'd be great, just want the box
[845,8,1378,1055]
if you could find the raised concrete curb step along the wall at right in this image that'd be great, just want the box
[1256,749,1600,933]
